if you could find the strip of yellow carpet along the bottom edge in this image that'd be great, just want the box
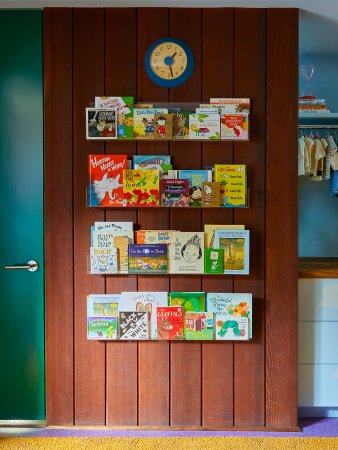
[0,437,338,450]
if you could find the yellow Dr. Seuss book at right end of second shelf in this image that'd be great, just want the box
[215,164,247,208]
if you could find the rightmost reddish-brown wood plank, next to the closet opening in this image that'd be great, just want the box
[266,9,299,427]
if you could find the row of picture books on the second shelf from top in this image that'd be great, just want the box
[87,155,248,208]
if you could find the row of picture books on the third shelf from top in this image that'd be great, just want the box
[89,222,250,275]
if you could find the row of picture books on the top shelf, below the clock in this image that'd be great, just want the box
[86,97,250,140]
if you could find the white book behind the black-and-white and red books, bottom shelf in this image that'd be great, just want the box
[121,292,168,339]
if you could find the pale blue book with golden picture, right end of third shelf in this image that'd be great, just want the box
[214,230,250,275]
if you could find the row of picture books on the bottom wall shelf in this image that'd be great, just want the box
[87,292,252,340]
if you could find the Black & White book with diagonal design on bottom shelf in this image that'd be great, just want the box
[119,311,149,340]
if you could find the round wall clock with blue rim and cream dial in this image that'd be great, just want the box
[144,38,195,87]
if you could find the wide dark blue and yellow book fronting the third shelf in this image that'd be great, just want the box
[128,244,168,274]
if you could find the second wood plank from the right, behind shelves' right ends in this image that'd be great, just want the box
[234,9,266,426]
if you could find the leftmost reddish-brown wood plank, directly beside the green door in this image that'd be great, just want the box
[43,8,74,425]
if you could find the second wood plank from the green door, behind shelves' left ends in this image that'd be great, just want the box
[73,8,106,425]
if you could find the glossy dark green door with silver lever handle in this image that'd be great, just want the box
[0,10,45,421]
